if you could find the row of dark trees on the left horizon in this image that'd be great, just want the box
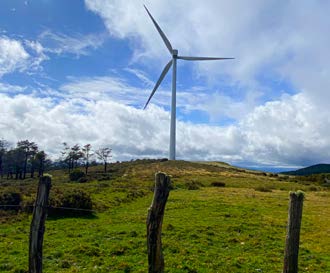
[0,139,111,179]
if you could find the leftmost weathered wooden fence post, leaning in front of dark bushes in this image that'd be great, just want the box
[29,175,51,273]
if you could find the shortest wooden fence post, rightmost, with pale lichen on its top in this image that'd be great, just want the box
[283,191,304,273]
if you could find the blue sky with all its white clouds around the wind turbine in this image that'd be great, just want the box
[0,0,330,168]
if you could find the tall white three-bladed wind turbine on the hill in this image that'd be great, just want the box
[143,6,234,160]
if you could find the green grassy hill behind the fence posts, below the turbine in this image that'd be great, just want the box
[0,160,330,273]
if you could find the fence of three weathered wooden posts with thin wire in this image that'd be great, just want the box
[0,173,304,273]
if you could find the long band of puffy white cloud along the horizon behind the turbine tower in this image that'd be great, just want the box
[0,91,330,166]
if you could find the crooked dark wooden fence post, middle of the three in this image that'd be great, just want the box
[147,172,171,273]
